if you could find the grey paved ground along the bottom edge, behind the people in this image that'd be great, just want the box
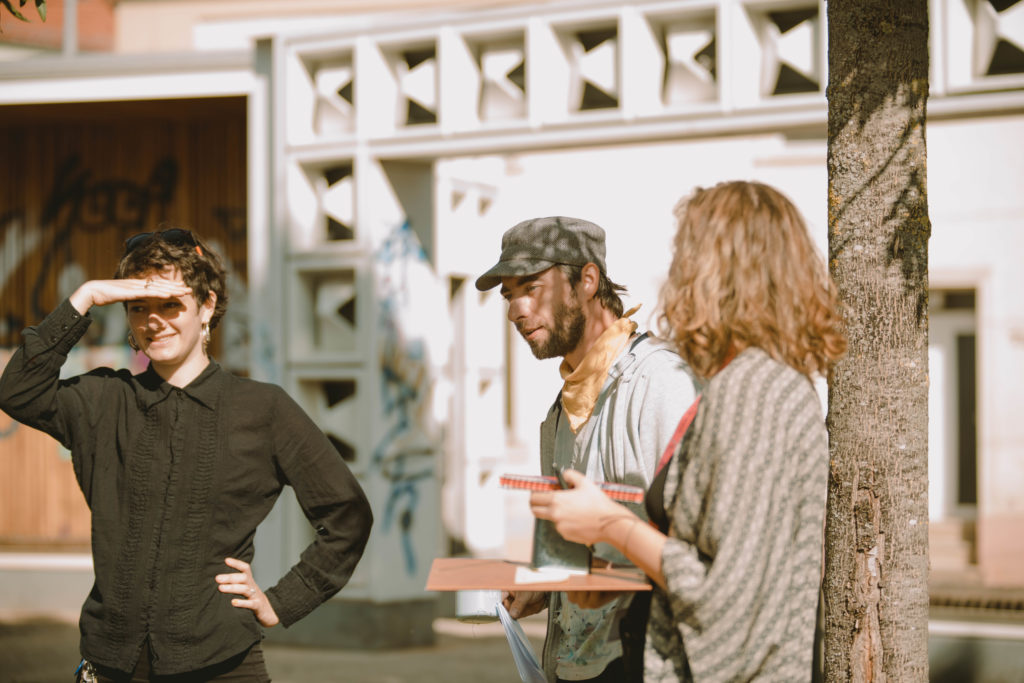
[0,609,1024,683]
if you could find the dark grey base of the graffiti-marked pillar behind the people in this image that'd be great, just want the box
[266,599,437,650]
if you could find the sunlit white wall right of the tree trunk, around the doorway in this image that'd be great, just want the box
[928,115,1024,516]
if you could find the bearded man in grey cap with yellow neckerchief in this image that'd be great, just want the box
[476,216,696,682]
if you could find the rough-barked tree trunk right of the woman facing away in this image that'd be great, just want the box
[824,0,931,683]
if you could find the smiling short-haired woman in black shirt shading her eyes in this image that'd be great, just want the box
[0,228,372,681]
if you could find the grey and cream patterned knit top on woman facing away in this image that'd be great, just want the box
[644,348,828,683]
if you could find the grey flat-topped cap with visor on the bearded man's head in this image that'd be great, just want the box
[476,216,607,292]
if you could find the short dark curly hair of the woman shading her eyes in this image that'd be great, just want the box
[114,226,227,330]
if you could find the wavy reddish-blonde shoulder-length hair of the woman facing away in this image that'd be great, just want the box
[658,181,846,379]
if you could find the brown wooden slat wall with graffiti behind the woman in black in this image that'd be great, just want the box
[0,97,246,545]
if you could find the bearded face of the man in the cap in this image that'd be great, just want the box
[502,267,587,359]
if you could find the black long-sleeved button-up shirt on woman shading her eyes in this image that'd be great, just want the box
[0,301,372,675]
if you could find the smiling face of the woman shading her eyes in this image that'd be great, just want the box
[126,268,216,379]
